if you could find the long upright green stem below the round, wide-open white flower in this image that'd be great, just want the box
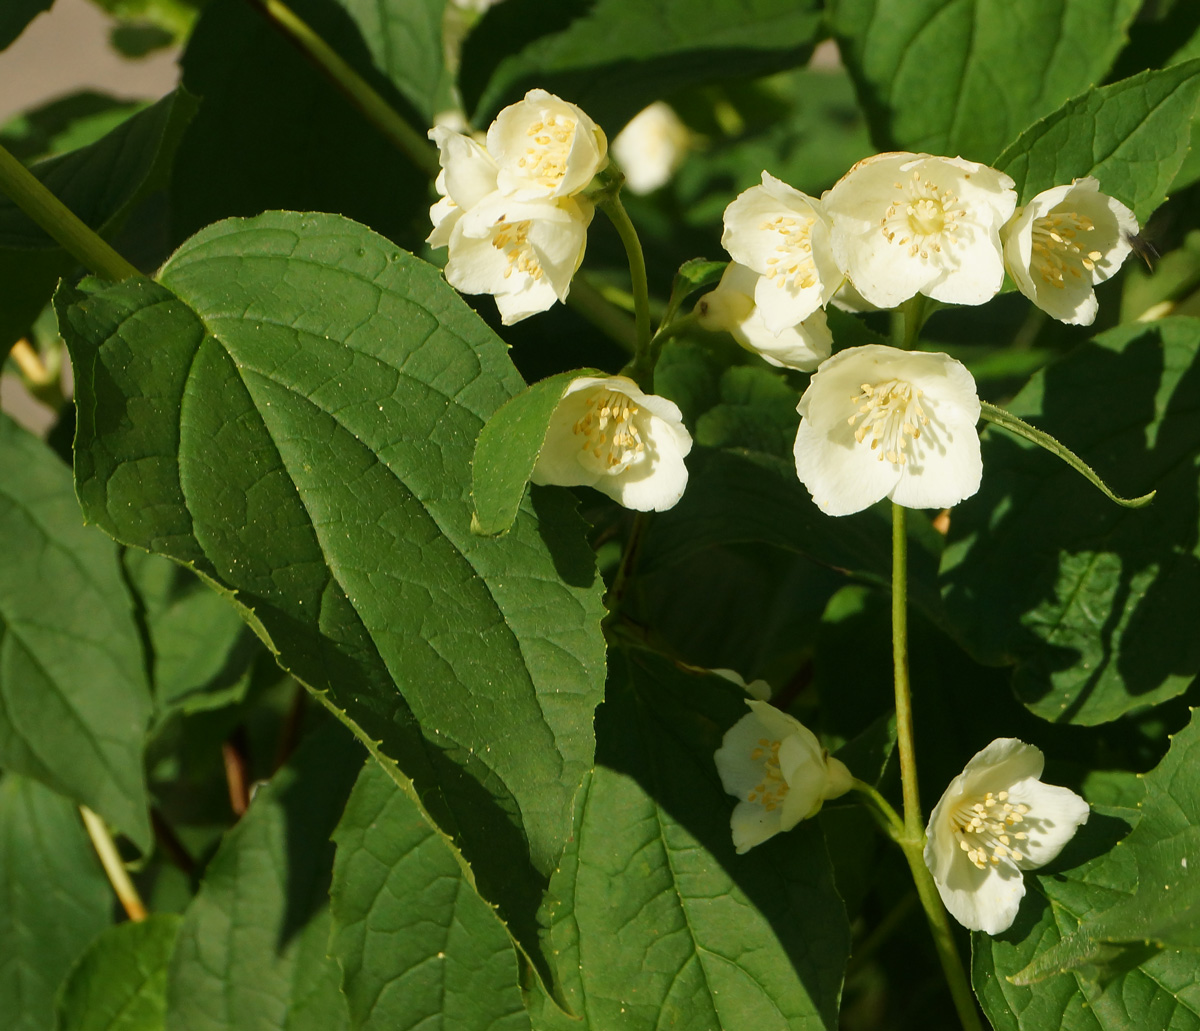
[888,502,983,1031]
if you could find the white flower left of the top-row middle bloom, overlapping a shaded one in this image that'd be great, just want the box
[721,172,842,334]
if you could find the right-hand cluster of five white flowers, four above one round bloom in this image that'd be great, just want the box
[696,152,1138,515]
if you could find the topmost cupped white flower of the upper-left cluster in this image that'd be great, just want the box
[487,90,608,199]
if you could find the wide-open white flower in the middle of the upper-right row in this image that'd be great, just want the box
[821,152,1016,308]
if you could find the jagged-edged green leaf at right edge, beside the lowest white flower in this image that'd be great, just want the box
[1015,709,1200,984]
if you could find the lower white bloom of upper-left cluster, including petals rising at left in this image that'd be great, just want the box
[426,126,594,325]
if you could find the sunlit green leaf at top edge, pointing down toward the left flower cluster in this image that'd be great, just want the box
[336,0,454,130]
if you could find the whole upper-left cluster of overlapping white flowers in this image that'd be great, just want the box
[426,90,608,325]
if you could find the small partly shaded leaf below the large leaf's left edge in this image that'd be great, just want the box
[124,551,262,721]
